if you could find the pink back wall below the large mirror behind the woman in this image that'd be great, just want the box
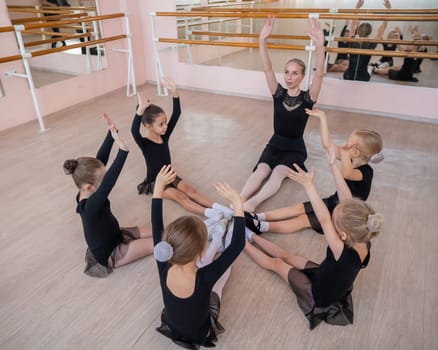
[143,1,438,121]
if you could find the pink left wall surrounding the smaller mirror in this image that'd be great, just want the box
[0,0,135,130]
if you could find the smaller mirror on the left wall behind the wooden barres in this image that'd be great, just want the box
[7,0,107,88]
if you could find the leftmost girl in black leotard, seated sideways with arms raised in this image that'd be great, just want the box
[64,114,153,277]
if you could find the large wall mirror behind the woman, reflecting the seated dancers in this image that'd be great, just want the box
[177,0,438,87]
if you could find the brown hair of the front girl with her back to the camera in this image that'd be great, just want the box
[163,216,208,265]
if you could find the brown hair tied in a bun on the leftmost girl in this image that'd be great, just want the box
[64,157,104,189]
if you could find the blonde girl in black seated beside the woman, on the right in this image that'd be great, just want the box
[246,109,383,234]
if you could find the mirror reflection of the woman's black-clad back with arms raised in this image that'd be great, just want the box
[343,0,391,81]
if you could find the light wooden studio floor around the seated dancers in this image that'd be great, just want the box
[0,86,438,350]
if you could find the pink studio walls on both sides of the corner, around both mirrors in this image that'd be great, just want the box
[0,0,438,130]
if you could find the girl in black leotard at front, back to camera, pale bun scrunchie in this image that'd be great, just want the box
[151,165,245,349]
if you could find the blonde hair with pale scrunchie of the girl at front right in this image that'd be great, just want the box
[333,198,384,245]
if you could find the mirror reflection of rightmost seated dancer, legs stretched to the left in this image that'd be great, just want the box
[374,26,427,83]
